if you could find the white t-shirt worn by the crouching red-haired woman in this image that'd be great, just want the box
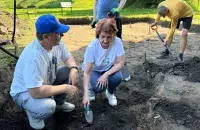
[82,37,125,72]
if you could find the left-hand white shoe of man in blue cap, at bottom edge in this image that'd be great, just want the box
[26,110,45,130]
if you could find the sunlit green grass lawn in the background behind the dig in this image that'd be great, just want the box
[0,0,200,21]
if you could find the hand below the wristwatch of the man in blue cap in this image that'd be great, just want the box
[69,68,79,86]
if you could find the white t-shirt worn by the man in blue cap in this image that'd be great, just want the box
[10,39,71,96]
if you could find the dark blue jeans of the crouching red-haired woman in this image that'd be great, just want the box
[89,71,122,94]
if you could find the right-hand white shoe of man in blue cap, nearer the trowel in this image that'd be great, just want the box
[56,102,75,112]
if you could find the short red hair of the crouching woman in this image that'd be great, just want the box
[96,18,118,38]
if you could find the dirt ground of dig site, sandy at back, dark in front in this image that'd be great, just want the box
[0,23,200,130]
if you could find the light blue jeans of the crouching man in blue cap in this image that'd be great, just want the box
[13,66,70,119]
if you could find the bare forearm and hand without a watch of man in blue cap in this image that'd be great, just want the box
[28,84,77,98]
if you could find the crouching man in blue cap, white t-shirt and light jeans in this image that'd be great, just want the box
[10,14,78,129]
